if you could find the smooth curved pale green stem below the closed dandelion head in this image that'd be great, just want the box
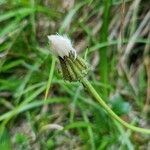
[80,78,150,134]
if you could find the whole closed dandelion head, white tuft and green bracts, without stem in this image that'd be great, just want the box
[48,35,89,81]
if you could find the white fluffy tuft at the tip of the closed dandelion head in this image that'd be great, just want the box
[48,35,76,58]
